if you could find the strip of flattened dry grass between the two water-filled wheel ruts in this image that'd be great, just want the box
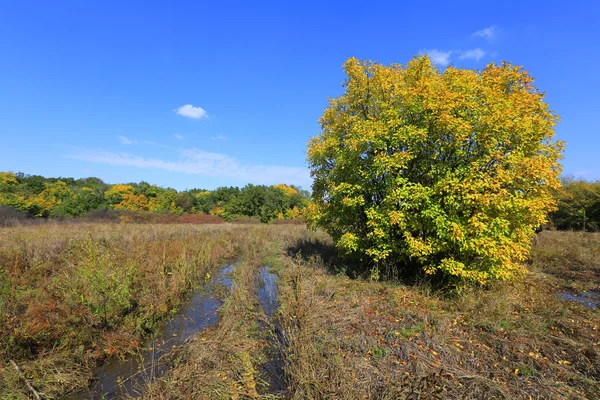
[143,227,296,399]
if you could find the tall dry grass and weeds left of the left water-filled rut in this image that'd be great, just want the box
[0,224,303,398]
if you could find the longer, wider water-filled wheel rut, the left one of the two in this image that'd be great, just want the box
[64,264,233,399]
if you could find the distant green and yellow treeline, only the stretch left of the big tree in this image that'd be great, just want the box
[0,172,310,222]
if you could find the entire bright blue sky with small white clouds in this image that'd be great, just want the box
[0,0,600,189]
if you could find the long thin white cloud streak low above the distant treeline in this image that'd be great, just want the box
[69,149,311,187]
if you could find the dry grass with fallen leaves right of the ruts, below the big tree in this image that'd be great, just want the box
[280,232,600,399]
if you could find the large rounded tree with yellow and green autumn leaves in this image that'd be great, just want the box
[308,56,563,283]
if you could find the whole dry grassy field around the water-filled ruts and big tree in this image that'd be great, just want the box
[0,224,600,399]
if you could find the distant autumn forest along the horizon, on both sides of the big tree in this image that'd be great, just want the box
[0,172,600,232]
